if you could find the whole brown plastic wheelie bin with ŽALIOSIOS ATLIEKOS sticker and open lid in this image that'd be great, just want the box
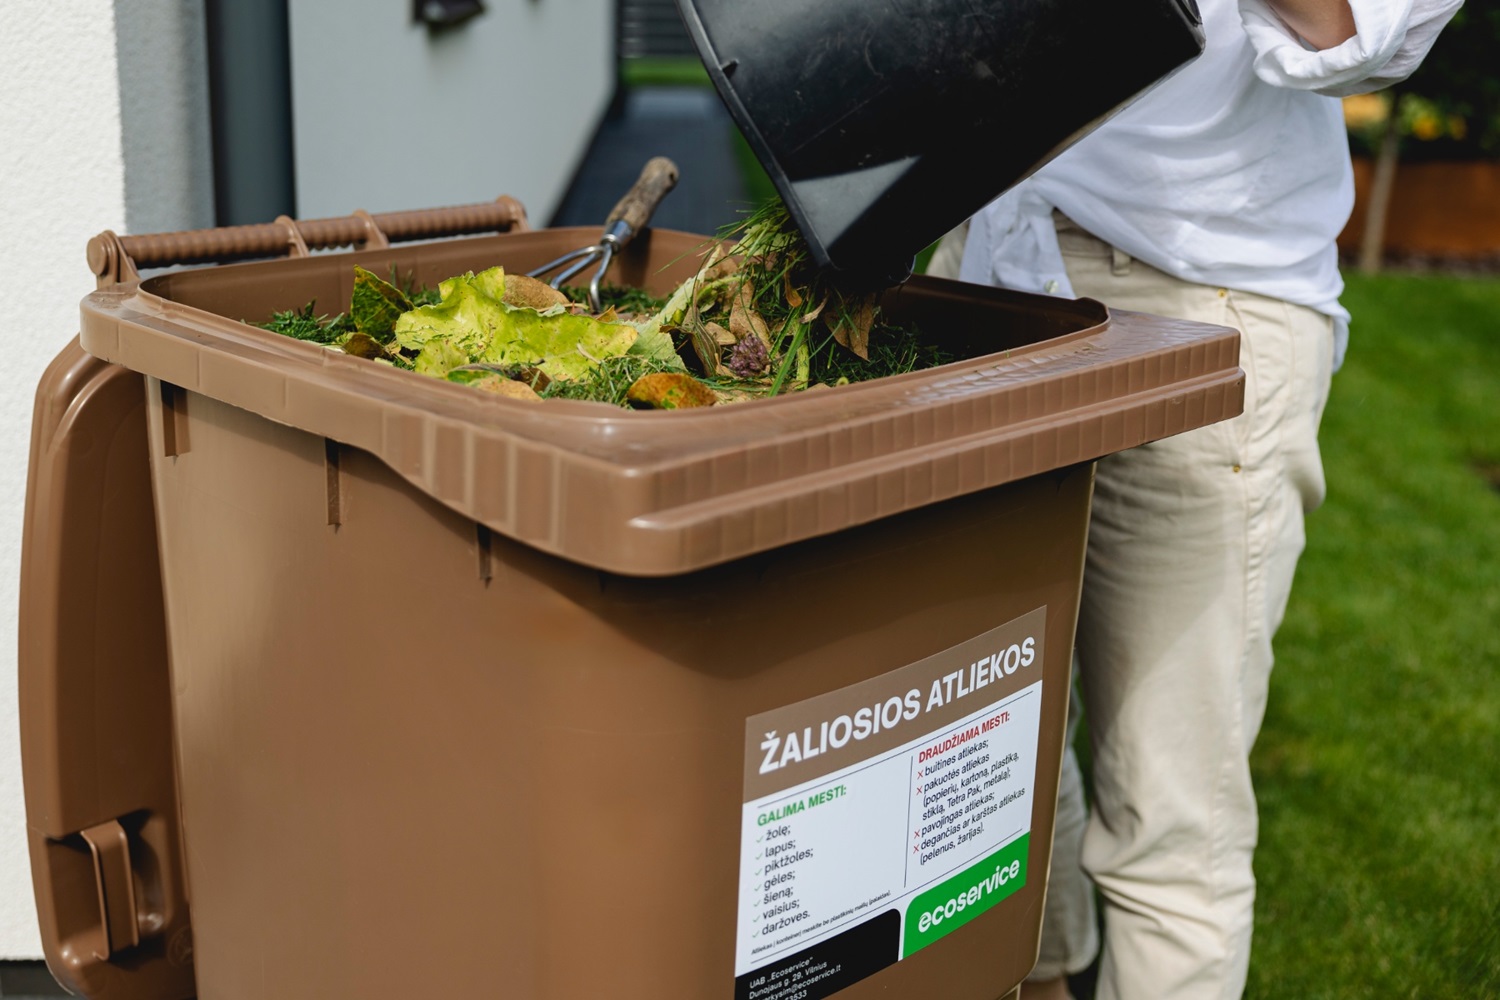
[21,202,1244,1000]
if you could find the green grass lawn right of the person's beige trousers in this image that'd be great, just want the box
[1247,269,1500,1000]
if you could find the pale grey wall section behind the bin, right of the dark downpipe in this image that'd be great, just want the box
[290,0,615,225]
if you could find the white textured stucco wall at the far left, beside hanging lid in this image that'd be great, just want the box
[0,0,213,958]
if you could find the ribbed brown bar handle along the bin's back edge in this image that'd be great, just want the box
[89,195,531,288]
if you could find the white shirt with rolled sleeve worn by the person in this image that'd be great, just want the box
[960,0,1463,367]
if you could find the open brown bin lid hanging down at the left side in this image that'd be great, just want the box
[17,340,197,1000]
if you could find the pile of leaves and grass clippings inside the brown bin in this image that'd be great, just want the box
[264,205,953,409]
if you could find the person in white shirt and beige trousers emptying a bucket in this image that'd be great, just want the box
[930,0,1461,1000]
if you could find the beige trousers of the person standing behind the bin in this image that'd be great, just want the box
[930,216,1334,1000]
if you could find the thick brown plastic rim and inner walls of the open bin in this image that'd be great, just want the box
[81,229,1245,576]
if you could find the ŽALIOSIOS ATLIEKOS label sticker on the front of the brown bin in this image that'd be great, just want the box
[735,609,1046,1000]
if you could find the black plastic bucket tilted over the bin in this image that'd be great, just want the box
[678,0,1203,276]
